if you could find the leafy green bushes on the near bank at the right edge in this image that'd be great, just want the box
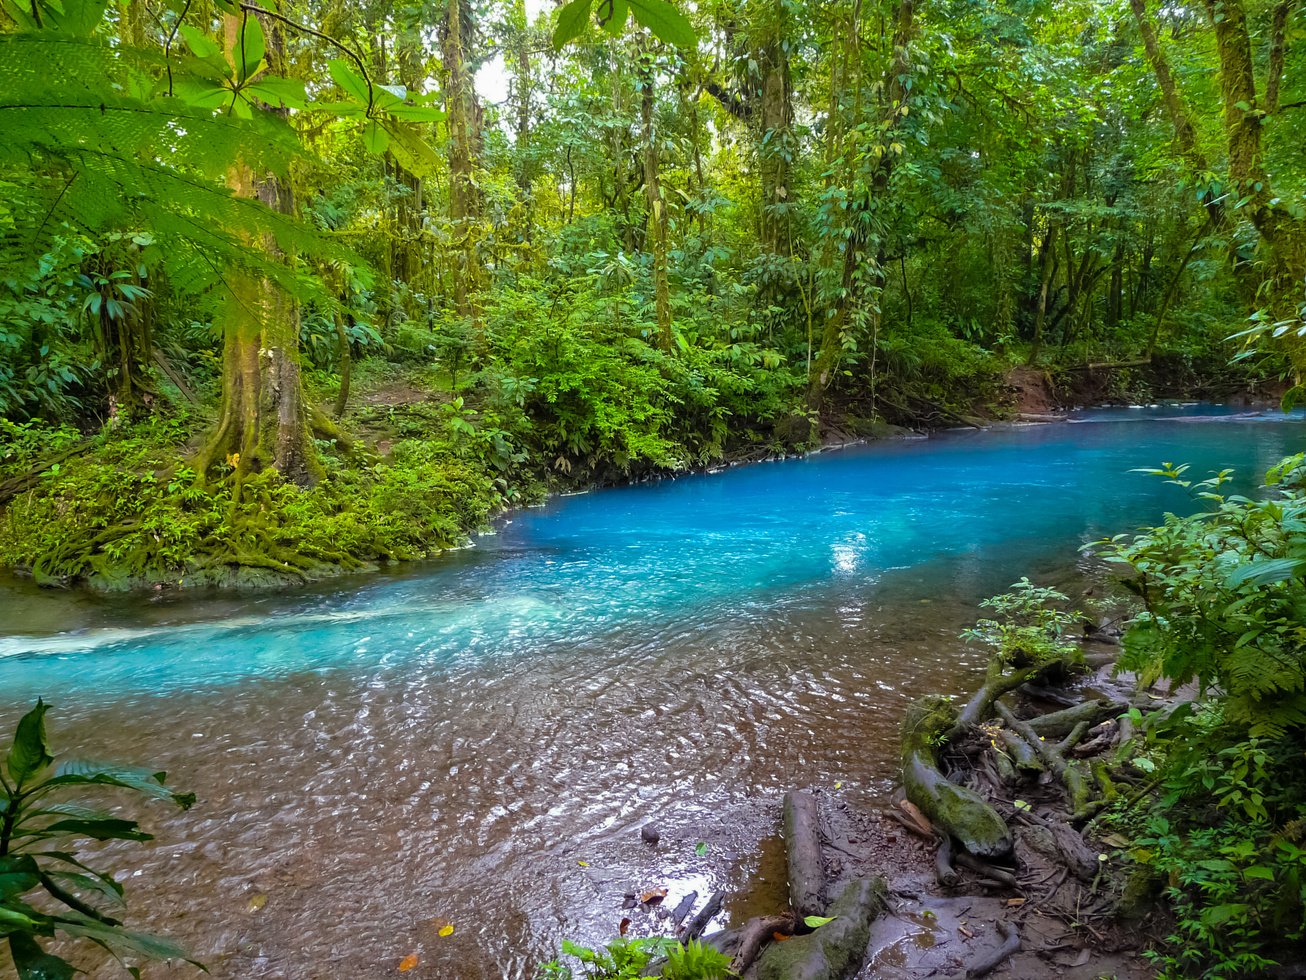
[1100,455,1306,977]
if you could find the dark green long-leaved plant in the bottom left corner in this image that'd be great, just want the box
[0,700,202,980]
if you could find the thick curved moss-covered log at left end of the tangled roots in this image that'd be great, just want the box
[902,698,1012,857]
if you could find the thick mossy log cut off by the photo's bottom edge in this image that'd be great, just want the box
[757,878,885,980]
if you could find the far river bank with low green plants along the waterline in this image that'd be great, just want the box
[0,355,1272,597]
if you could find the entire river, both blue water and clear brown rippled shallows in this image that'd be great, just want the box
[0,406,1306,980]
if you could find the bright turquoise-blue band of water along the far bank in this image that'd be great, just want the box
[0,406,1306,702]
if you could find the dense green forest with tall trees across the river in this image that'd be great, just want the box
[0,0,1303,584]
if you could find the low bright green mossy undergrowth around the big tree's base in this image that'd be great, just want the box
[0,419,505,591]
